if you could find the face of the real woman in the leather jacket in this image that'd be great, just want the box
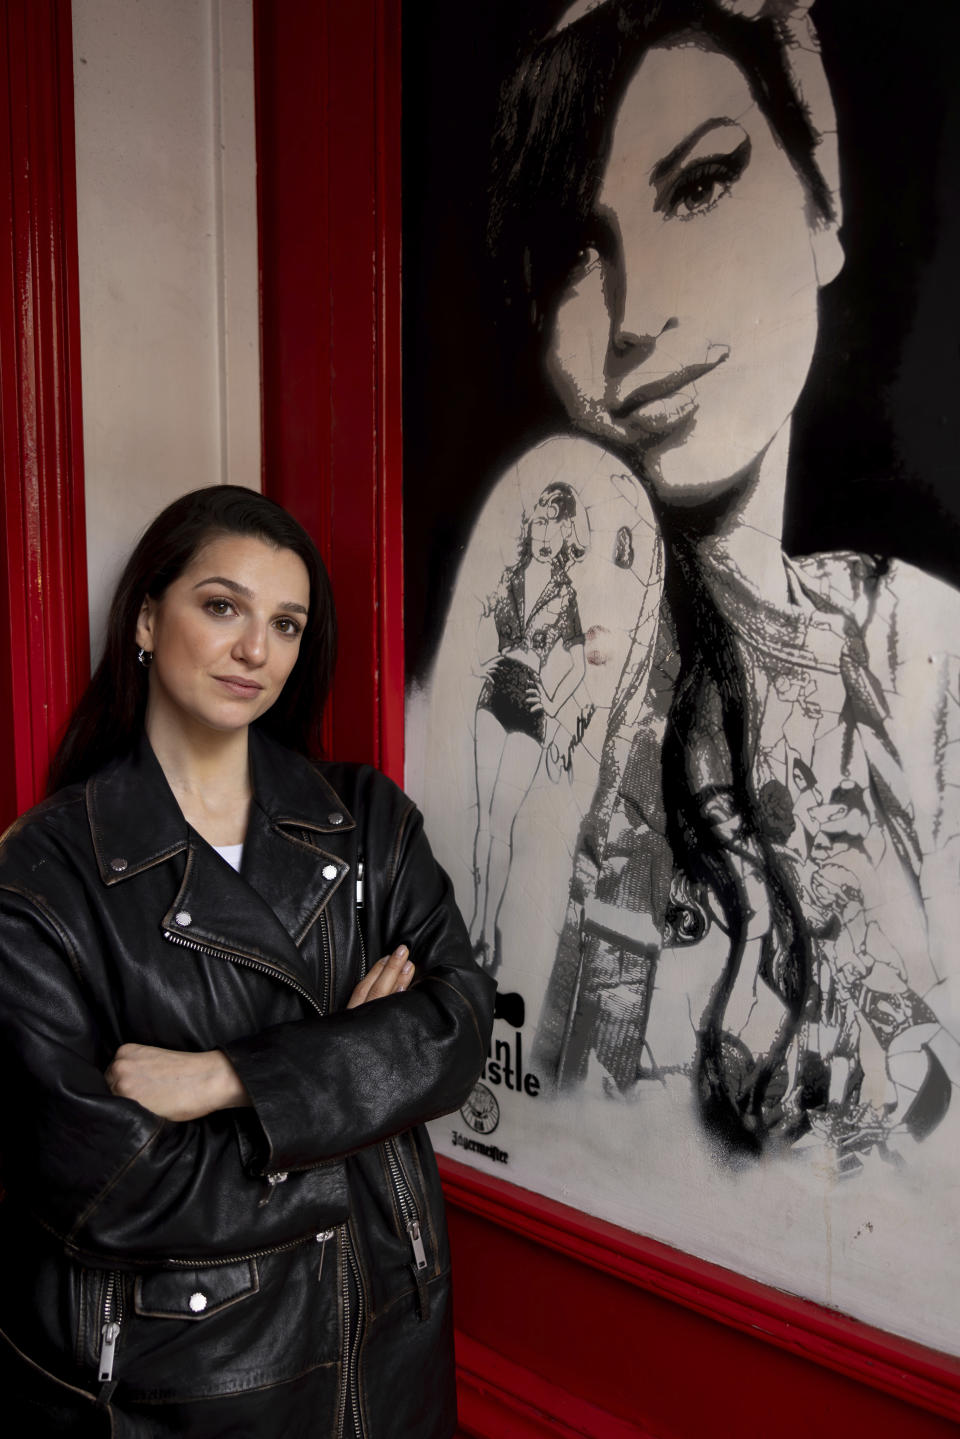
[137,535,309,731]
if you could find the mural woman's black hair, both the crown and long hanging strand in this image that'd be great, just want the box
[488,0,839,1154]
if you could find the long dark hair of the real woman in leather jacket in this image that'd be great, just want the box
[47,485,337,793]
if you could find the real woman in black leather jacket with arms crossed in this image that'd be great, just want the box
[0,486,492,1439]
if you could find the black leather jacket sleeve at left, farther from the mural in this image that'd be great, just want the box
[0,891,348,1268]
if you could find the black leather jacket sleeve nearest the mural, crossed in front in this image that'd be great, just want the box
[226,794,495,1170]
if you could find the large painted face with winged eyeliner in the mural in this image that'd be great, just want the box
[547,45,834,505]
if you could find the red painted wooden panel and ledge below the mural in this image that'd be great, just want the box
[442,1160,960,1439]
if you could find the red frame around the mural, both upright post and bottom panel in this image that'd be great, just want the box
[255,0,960,1439]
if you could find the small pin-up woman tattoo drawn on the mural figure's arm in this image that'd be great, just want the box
[471,482,586,974]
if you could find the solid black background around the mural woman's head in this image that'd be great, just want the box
[403,0,960,678]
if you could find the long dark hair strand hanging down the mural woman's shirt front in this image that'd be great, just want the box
[662,534,813,1153]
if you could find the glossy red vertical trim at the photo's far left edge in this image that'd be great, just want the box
[0,0,89,825]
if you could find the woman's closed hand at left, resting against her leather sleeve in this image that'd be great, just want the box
[105,1045,250,1122]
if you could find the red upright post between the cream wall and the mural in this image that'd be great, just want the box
[255,0,403,780]
